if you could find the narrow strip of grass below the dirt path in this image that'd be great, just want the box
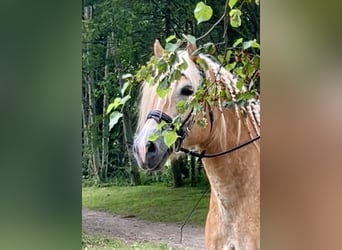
[82,234,175,250]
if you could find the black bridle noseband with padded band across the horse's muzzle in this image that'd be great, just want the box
[146,110,193,152]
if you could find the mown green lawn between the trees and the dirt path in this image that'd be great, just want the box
[82,186,209,225]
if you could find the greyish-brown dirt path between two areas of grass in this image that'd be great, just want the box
[82,208,204,250]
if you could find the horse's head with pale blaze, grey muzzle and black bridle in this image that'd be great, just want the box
[133,40,209,170]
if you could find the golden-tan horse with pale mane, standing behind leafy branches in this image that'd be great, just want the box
[133,40,260,250]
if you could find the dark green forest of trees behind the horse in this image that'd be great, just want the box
[82,0,260,187]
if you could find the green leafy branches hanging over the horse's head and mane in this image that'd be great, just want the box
[112,0,260,150]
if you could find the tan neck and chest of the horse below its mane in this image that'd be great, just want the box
[202,107,260,249]
